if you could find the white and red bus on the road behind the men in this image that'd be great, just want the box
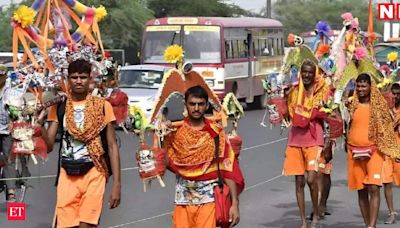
[141,17,284,107]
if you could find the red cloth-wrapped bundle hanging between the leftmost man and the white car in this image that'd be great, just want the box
[108,89,129,124]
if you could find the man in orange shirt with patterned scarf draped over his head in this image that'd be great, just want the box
[347,73,399,227]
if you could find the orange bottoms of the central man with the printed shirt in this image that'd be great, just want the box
[172,202,216,228]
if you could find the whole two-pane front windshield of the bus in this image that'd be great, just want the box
[144,25,221,63]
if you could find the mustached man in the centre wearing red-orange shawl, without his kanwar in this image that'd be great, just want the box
[162,86,244,228]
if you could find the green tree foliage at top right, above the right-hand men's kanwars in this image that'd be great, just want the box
[270,0,383,40]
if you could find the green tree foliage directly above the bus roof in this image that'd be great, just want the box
[147,0,250,18]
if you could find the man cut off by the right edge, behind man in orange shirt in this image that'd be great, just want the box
[383,83,400,224]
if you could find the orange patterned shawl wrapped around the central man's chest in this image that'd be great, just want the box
[166,119,235,179]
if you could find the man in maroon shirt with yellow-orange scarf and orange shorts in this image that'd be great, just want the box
[283,60,329,228]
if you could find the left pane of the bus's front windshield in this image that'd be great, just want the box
[142,26,181,63]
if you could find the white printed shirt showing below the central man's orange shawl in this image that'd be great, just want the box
[175,175,217,205]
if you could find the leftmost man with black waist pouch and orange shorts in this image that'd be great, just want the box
[39,59,121,228]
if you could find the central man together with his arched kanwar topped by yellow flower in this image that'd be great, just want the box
[150,45,244,228]
